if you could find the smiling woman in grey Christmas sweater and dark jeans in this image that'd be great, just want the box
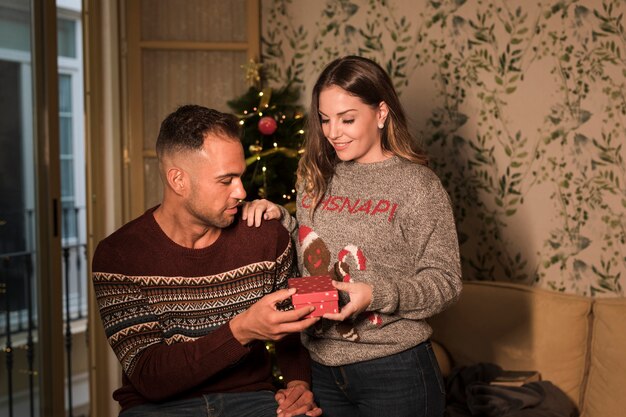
[242,56,462,417]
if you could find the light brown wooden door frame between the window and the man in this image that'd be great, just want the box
[83,0,124,417]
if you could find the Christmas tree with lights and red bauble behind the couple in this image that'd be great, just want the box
[228,60,305,211]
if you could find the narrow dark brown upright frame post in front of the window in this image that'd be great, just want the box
[31,1,64,416]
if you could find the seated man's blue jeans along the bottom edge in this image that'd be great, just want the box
[120,391,306,417]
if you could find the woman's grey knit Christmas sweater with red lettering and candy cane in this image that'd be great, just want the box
[284,157,462,366]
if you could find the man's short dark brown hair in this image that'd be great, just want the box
[156,104,241,159]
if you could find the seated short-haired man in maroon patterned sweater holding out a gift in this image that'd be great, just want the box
[93,105,321,417]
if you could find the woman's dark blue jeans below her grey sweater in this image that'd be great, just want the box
[312,341,445,417]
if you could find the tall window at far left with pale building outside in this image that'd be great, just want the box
[0,0,89,416]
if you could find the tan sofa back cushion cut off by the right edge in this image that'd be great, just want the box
[583,298,626,417]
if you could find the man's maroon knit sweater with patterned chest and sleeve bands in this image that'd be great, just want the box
[93,208,310,409]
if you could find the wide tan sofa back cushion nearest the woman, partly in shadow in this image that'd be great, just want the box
[429,281,592,405]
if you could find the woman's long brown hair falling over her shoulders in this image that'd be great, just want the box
[297,56,428,215]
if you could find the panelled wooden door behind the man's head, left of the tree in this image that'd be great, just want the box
[122,0,260,221]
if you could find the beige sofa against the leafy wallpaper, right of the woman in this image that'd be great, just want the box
[430,281,626,417]
